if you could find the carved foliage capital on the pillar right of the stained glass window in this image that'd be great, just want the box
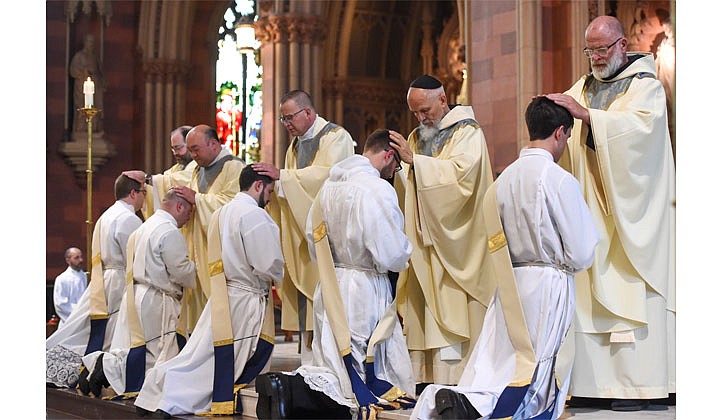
[255,15,327,45]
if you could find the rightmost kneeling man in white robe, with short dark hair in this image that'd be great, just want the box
[411,97,599,419]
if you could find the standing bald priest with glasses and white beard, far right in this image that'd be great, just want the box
[547,16,675,411]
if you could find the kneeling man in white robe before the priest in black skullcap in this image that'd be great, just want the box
[255,130,415,419]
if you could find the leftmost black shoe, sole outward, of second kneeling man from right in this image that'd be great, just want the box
[255,372,292,420]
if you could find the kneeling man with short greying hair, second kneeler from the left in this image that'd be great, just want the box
[83,190,195,397]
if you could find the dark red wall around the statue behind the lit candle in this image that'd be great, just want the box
[45,1,142,279]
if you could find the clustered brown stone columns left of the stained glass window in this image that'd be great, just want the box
[138,0,195,172]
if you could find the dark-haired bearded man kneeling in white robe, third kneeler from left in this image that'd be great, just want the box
[135,165,284,416]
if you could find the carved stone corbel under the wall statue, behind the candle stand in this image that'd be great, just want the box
[58,132,116,185]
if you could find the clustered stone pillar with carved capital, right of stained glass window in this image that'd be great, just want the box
[255,6,326,167]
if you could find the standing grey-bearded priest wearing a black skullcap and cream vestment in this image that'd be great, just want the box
[390,75,493,393]
